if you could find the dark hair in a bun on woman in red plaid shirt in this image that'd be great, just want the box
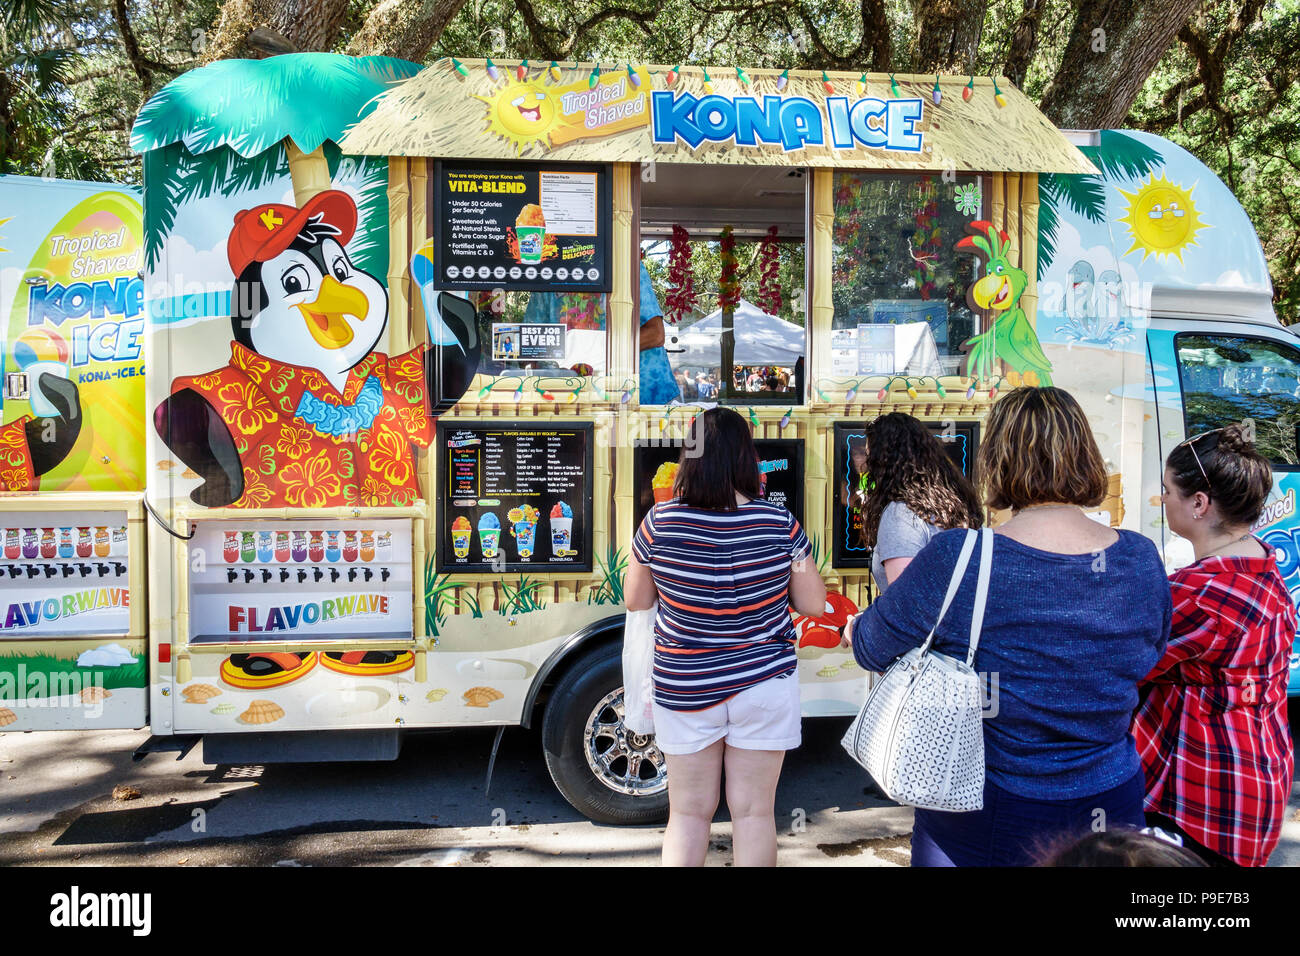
[1165,425,1273,527]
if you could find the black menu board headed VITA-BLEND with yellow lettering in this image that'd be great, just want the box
[433,163,612,293]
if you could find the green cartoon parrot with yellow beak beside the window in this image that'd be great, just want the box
[957,220,1052,385]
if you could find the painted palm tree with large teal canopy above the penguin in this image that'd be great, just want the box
[131,53,420,268]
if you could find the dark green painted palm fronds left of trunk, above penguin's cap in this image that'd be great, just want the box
[144,143,287,269]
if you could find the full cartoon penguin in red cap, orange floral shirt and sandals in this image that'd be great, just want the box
[153,190,480,688]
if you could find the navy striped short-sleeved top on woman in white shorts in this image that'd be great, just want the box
[632,498,810,710]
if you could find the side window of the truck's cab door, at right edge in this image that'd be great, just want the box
[1174,334,1300,466]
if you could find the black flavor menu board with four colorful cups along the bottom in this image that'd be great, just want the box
[437,421,593,574]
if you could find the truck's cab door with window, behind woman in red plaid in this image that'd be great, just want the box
[1147,319,1300,693]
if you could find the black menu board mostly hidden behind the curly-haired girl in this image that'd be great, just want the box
[831,421,979,567]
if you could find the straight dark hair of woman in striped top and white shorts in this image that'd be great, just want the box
[673,407,759,511]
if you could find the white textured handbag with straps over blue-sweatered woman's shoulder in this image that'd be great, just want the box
[841,528,993,810]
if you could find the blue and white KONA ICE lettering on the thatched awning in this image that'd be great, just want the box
[651,90,924,152]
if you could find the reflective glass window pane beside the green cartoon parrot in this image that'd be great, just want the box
[831,170,988,377]
